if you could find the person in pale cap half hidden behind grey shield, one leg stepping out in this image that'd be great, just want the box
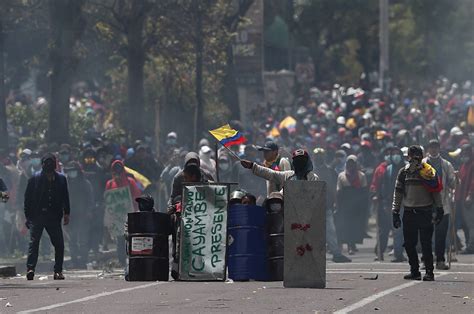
[313,148,352,263]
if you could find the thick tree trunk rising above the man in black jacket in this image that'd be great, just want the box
[48,0,85,143]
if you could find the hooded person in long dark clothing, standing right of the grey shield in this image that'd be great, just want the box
[335,155,369,255]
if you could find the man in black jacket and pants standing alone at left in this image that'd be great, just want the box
[24,154,70,280]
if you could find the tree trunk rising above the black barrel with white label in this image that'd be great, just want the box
[124,9,145,139]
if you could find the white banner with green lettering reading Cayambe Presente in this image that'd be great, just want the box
[179,184,229,281]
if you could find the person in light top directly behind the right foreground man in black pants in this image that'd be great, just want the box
[426,139,456,270]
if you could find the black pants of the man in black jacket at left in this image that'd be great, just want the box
[26,219,64,273]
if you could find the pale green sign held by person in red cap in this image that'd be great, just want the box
[104,186,133,237]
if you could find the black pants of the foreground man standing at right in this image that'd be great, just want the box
[403,208,434,272]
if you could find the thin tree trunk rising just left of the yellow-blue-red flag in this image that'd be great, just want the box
[193,1,204,147]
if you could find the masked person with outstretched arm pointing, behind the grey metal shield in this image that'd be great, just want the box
[241,149,319,187]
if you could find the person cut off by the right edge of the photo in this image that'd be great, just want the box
[455,144,474,254]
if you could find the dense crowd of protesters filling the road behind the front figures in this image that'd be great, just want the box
[0,78,474,274]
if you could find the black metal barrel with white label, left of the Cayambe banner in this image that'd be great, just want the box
[127,212,171,281]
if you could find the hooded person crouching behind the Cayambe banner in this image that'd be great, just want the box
[168,152,215,212]
